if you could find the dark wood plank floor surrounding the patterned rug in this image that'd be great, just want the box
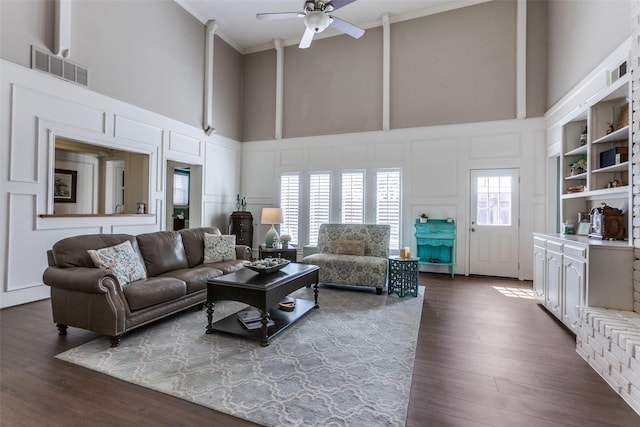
[0,273,640,427]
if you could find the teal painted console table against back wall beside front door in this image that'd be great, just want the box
[415,218,456,277]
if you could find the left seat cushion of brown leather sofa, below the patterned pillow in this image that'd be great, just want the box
[122,277,187,311]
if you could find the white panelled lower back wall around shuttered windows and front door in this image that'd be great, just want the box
[241,119,546,280]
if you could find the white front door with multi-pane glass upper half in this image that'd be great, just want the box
[469,169,520,278]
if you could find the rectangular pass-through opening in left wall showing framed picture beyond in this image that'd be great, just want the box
[51,136,149,215]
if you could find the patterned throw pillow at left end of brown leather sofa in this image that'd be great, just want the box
[87,240,147,285]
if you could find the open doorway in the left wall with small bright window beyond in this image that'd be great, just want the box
[166,160,202,231]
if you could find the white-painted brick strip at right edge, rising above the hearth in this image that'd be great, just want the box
[628,0,640,313]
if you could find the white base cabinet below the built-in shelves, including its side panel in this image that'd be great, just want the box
[533,233,634,332]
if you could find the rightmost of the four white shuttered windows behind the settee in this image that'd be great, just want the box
[376,169,400,249]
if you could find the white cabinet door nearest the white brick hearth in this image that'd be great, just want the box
[562,256,586,333]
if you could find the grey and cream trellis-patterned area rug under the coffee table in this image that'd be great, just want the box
[56,286,424,427]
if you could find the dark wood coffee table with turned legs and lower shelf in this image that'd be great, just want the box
[205,263,320,347]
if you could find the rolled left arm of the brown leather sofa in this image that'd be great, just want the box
[42,266,120,294]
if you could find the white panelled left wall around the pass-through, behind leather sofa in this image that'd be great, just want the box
[0,60,240,307]
